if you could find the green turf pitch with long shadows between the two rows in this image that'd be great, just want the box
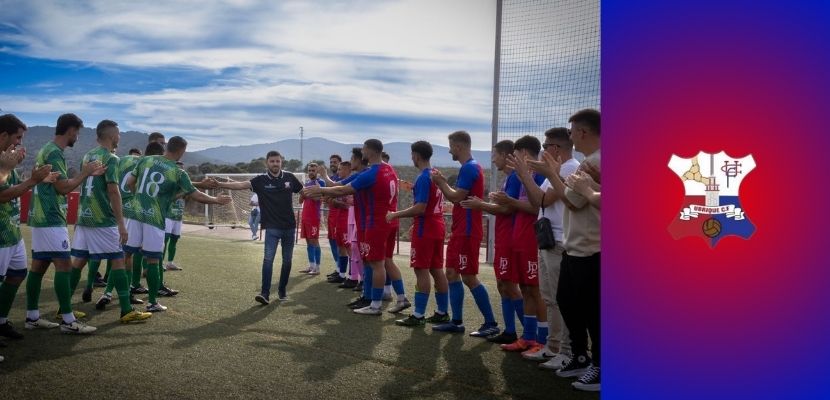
[0,228,599,400]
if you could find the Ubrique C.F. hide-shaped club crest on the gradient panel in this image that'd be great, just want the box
[669,152,755,247]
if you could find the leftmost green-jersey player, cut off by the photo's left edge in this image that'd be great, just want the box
[0,114,57,348]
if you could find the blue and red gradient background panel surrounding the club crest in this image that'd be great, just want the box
[602,1,830,399]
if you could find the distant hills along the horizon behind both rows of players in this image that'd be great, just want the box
[16,126,490,173]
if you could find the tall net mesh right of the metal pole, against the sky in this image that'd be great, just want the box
[496,0,600,140]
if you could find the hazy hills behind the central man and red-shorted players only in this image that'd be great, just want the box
[193,138,490,168]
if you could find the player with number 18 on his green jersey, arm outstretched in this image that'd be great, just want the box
[124,136,231,312]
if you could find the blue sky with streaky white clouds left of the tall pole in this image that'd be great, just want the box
[0,0,495,150]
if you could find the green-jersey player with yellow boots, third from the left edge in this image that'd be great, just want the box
[72,120,152,323]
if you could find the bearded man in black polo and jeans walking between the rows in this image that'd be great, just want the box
[219,150,303,304]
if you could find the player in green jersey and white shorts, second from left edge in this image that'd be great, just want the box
[25,114,106,334]
